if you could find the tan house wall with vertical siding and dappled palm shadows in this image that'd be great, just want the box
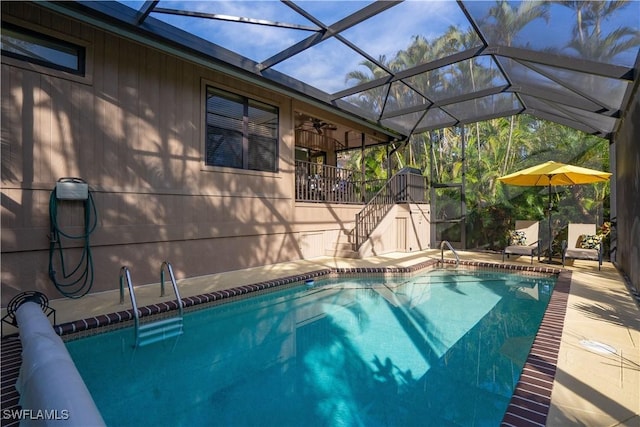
[1,2,430,306]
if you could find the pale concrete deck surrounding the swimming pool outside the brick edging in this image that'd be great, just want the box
[5,250,640,427]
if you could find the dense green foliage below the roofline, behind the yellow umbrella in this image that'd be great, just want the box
[350,116,610,255]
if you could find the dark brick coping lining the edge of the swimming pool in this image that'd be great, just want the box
[0,260,571,427]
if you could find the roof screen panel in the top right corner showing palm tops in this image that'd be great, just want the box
[464,1,640,67]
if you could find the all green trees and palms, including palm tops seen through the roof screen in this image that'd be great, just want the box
[338,0,628,250]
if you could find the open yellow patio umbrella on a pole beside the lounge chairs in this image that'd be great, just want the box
[498,161,611,262]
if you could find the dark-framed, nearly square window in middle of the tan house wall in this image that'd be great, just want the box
[205,87,278,172]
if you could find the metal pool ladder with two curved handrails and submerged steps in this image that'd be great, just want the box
[120,261,184,347]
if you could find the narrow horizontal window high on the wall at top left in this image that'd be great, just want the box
[1,22,85,76]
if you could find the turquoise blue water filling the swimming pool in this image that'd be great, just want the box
[66,271,555,427]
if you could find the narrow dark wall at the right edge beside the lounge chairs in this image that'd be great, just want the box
[611,86,640,291]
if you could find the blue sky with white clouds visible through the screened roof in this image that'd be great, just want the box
[122,0,640,93]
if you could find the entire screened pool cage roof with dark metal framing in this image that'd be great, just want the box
[107,0,640,137]
